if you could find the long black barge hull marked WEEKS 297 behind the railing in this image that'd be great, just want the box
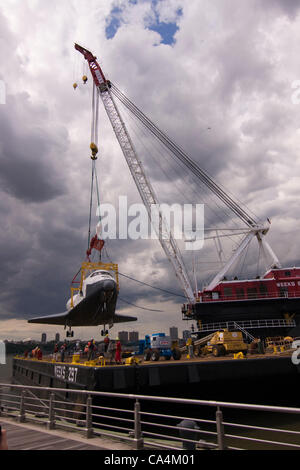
[13,351,300,404]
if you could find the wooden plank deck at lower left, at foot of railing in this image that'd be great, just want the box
[0,417,133,450]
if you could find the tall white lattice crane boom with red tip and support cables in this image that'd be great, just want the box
[75,44,280,303]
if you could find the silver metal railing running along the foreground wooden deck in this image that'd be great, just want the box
[0,384,300,450]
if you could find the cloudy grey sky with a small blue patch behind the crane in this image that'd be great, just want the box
[0,0,300,339]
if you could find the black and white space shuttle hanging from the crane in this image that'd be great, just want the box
[28,269,137,336]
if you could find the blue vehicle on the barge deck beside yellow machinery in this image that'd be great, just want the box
[137,333,181,361]
